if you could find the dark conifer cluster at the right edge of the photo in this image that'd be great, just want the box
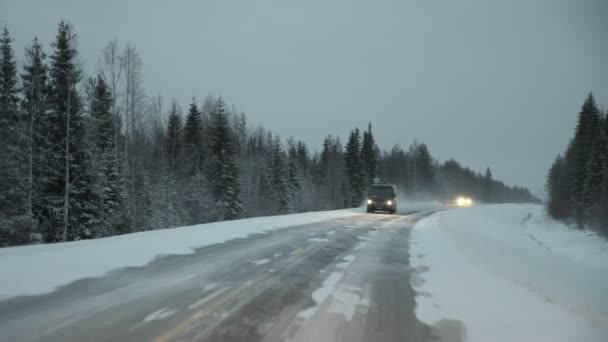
[547,93,608,234]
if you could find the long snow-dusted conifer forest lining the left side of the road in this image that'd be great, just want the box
[0,21,532,246]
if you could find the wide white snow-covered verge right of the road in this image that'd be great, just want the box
[410,205,608,342]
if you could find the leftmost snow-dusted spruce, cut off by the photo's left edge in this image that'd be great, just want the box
[0,27,36,247]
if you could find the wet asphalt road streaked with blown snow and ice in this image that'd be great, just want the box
[0,213,448,342]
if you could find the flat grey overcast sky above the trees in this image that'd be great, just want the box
[0,0,608,193]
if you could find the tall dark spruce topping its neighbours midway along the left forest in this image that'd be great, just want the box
[209,97,242,220]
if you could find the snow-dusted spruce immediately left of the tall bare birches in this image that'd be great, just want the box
[89,75,126,236]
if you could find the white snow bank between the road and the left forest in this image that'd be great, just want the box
[0,209,362,299]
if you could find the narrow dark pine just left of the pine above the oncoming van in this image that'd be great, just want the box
[344,128,365,207]
